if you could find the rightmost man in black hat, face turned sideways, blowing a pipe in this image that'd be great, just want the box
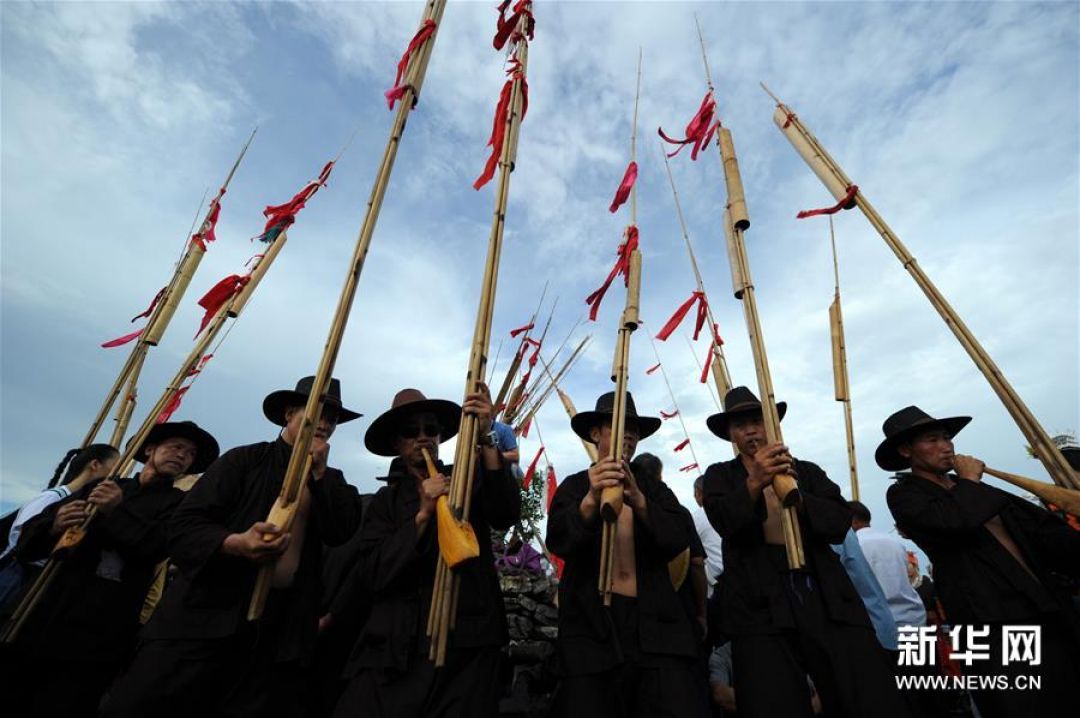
[875,406,1080,718]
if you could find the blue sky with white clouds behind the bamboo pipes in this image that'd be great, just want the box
[0,0,1080,557]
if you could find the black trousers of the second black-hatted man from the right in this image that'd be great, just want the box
[731,572,908,718]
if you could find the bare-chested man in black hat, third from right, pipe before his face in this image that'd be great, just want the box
[546,392,701,718]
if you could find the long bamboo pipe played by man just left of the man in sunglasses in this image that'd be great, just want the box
[247,0,446,621]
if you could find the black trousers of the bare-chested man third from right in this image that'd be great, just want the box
[551,595,707,718]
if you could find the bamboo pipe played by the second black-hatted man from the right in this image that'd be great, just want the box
[719,127,806,569]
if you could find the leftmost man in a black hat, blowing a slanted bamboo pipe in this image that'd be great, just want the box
[3,421,218,717]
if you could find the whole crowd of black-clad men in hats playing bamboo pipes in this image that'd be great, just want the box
[0,377,1080,718]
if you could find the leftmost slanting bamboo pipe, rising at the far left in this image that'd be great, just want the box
[81,128,257,448]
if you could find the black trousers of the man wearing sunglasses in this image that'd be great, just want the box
[334,646,502,718]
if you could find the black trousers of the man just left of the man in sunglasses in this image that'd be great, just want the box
[102,635,307,718]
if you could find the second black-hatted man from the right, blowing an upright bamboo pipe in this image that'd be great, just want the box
[704,387,906,718]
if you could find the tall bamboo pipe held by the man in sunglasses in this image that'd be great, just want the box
[428,13,529,667]
